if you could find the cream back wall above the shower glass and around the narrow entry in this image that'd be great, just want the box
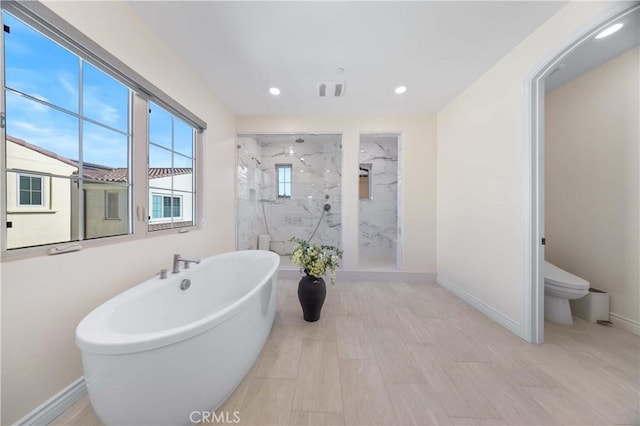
[236,116,436,273]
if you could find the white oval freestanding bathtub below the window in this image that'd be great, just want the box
[76,250,280,425]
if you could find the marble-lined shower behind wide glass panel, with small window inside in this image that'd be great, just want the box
[236,134,342,266]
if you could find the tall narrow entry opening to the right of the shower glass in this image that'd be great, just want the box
[358,133,401,270]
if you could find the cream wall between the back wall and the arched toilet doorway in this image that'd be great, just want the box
[437,2,619,337]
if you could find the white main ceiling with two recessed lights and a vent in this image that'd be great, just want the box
[128,0,565,115]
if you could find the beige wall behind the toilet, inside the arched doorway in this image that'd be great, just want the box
[545,47,640,328]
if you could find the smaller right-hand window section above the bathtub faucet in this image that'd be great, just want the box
[148,102,196,231]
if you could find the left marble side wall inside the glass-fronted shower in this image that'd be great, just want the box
[236,136,266,250]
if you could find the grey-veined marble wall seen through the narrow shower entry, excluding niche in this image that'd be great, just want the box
[359,135,398,263]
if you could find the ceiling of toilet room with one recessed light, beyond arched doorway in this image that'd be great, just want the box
[545,9,640,91]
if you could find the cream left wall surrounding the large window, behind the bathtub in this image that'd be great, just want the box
[1,2,235,424]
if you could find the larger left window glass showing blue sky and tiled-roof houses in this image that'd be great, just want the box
[3,12,131,249]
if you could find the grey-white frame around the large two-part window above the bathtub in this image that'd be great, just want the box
[0,4,207,262]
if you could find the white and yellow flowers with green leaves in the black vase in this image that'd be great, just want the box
[289,237,342,284]
